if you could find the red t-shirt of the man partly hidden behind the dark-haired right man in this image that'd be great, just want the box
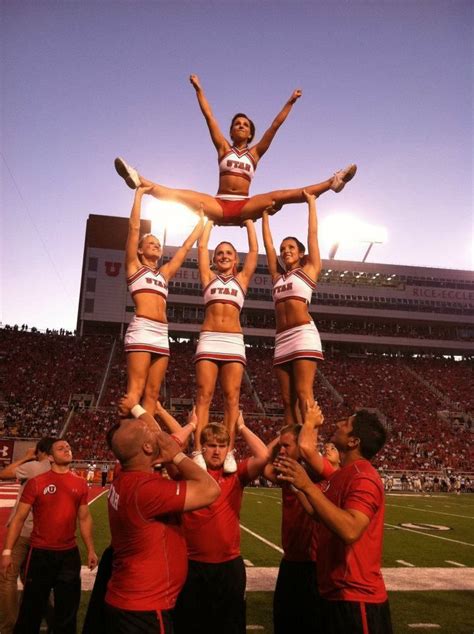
[281,457,335,561]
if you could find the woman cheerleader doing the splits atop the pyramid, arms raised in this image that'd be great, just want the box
[115,75,357,225]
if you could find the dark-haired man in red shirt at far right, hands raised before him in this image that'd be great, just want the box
[278,410,392,634]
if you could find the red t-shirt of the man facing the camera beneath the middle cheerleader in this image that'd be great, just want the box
[182,460,249,564]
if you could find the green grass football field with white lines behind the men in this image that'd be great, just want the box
[79,489,474,634]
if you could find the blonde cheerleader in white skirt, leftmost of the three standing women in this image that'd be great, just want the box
[124,187,204,416]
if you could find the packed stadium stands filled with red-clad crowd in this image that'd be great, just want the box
[0,328,474,472]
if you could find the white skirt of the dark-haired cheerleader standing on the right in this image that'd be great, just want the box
[273,321,324,365]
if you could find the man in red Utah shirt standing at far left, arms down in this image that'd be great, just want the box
[1,439,97,634]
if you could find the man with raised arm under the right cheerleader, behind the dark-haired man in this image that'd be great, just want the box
[264,402,339,634]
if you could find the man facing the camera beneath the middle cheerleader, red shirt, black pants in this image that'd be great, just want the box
[173,412,268,634]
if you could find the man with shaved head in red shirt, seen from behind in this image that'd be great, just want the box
[105,405,220,634]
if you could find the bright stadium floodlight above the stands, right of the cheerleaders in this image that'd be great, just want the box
[321,214,387,262]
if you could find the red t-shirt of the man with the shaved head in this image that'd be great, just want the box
[105,471,187,610]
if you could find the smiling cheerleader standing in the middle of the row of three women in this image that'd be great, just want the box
[194,220,258,473]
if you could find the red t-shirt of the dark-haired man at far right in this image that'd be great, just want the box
[318,459,387,603]
